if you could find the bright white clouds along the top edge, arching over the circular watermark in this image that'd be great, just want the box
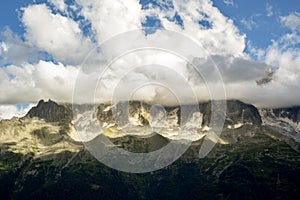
[78,0,245,55]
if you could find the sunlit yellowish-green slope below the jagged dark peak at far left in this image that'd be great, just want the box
[0,118,81,157]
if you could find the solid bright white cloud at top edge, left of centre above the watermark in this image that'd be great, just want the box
[77,0,142,44]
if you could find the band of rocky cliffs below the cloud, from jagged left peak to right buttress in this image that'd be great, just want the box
[15,100,261,143]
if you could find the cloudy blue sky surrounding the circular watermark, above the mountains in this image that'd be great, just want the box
[0,0,300,118]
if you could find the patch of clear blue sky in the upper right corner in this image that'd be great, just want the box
[213,0,300,48]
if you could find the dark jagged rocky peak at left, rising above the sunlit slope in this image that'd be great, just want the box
[26,100,72,123]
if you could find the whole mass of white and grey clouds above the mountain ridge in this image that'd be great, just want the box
[0,0,300,113]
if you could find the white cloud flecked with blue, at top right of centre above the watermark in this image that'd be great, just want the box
[146,0,245,56]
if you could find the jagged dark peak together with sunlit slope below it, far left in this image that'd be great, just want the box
[0,100,82,157]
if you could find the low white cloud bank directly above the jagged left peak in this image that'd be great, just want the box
[0,61,78,104]
